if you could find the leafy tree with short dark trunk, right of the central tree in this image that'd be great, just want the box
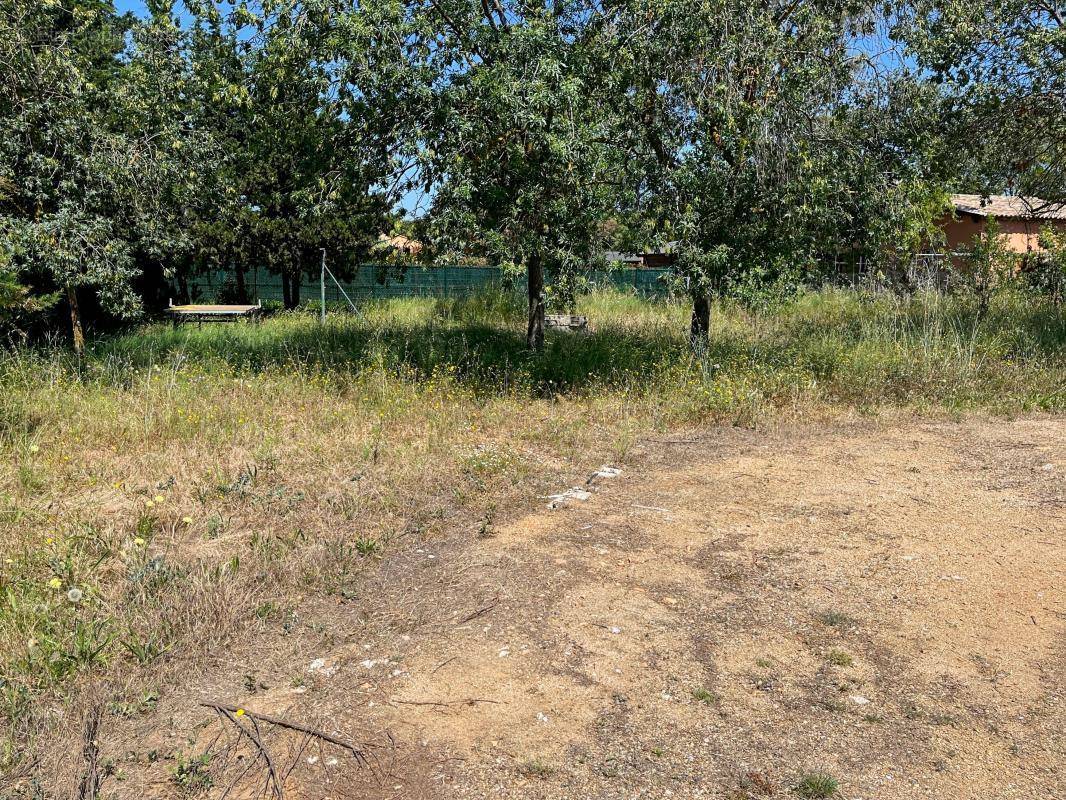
[611,0,925,346]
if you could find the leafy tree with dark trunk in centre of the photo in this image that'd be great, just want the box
[416,0,618,350]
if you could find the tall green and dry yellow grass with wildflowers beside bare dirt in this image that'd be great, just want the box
[0,291,1066,770]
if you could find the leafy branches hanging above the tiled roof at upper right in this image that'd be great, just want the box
[894,0,1066,203]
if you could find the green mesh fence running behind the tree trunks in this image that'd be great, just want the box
[178,265,669,303]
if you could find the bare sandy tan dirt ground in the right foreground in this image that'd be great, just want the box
[87,417,1066,800]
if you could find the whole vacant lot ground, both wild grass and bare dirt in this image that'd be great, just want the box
[0,295,1066,798]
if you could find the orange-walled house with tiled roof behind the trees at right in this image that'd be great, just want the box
[940,194,1066,254]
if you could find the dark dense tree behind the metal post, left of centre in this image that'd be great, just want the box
[176,0,416,308]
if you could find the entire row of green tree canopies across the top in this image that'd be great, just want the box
[0,0,1066,348]
